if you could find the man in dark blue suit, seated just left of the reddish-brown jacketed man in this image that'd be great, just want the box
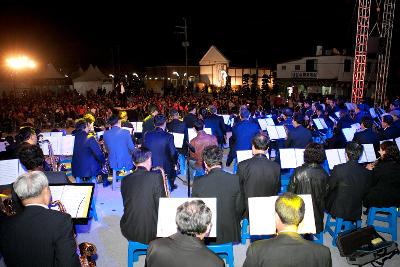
[143,114,178,190]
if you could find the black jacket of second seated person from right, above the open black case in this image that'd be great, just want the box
[326,161,371,221]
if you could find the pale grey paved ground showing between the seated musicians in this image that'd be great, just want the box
[78,153,400,267]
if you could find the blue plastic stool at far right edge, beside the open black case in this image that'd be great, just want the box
[367,207,397,241]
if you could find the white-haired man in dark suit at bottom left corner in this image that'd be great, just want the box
[0,171,81,267]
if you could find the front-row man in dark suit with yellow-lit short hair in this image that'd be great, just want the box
[243,193,332,267]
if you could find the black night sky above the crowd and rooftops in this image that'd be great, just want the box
[0,0,400,75]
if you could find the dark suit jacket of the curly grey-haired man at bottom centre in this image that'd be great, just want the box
[146,233,225,267]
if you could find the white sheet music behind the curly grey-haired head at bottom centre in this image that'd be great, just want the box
[157,198,217,237]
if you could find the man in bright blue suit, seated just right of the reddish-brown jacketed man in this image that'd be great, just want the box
[226,108,260,166]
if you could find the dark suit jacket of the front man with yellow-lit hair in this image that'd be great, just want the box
[243,232,332,267]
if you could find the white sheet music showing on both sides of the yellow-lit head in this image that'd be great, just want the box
[248,195,316,235]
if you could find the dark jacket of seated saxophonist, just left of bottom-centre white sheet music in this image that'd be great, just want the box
[120,167,165,244]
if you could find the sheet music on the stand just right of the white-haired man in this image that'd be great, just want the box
[50,185,94,218]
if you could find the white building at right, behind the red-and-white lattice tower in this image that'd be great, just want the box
[276,48,376,97]
